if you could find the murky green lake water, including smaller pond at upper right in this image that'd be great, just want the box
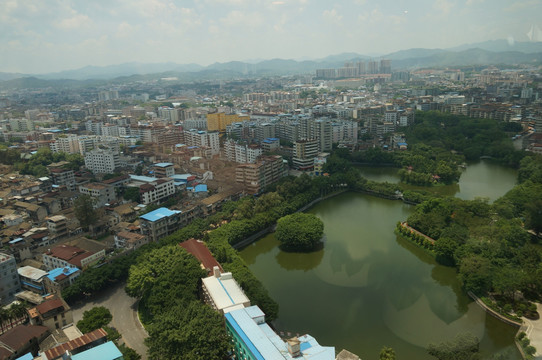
[241,162,521,360]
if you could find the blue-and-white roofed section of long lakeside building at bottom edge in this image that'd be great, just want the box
[224,306,335,360]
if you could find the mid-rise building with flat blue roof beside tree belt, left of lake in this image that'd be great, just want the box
[139,207,183,241]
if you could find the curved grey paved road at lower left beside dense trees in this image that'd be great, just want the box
[72,283,147,360]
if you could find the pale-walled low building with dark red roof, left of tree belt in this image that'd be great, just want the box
[42,244,105,270]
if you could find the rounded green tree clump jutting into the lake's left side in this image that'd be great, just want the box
[275,213,324,251]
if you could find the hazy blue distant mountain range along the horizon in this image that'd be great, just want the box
[0,40,542,89]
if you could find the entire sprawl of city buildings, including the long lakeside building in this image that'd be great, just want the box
[0,60,542,359]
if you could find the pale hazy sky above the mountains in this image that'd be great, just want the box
[0,0,542,73]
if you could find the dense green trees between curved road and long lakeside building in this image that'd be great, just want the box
[126,244,229,360]
